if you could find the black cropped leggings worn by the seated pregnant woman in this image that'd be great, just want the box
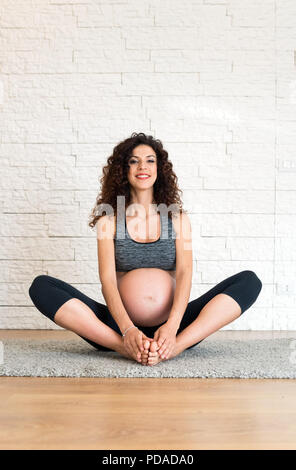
[29,270,262,351]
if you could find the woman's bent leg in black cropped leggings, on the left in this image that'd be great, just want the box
[29,274,122,352]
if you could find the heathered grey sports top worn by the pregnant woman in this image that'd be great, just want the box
[114,212,176,271]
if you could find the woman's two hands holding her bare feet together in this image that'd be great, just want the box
[123,321,178,362]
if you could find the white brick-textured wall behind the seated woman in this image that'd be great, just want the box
[0,0,296,330]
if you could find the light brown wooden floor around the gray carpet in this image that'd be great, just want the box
[0,330,296,450]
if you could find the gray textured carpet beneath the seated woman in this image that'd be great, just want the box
[0,338,296,379]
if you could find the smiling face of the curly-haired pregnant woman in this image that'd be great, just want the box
[127,144,157,190]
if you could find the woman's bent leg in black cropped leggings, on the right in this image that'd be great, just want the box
[170,270,262,354]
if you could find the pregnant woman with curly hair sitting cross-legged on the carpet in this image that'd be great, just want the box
[29,133,262,366]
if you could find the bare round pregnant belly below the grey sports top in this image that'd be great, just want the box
[118,268,176,326]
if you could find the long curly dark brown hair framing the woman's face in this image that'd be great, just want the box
[88,132,186,228]
